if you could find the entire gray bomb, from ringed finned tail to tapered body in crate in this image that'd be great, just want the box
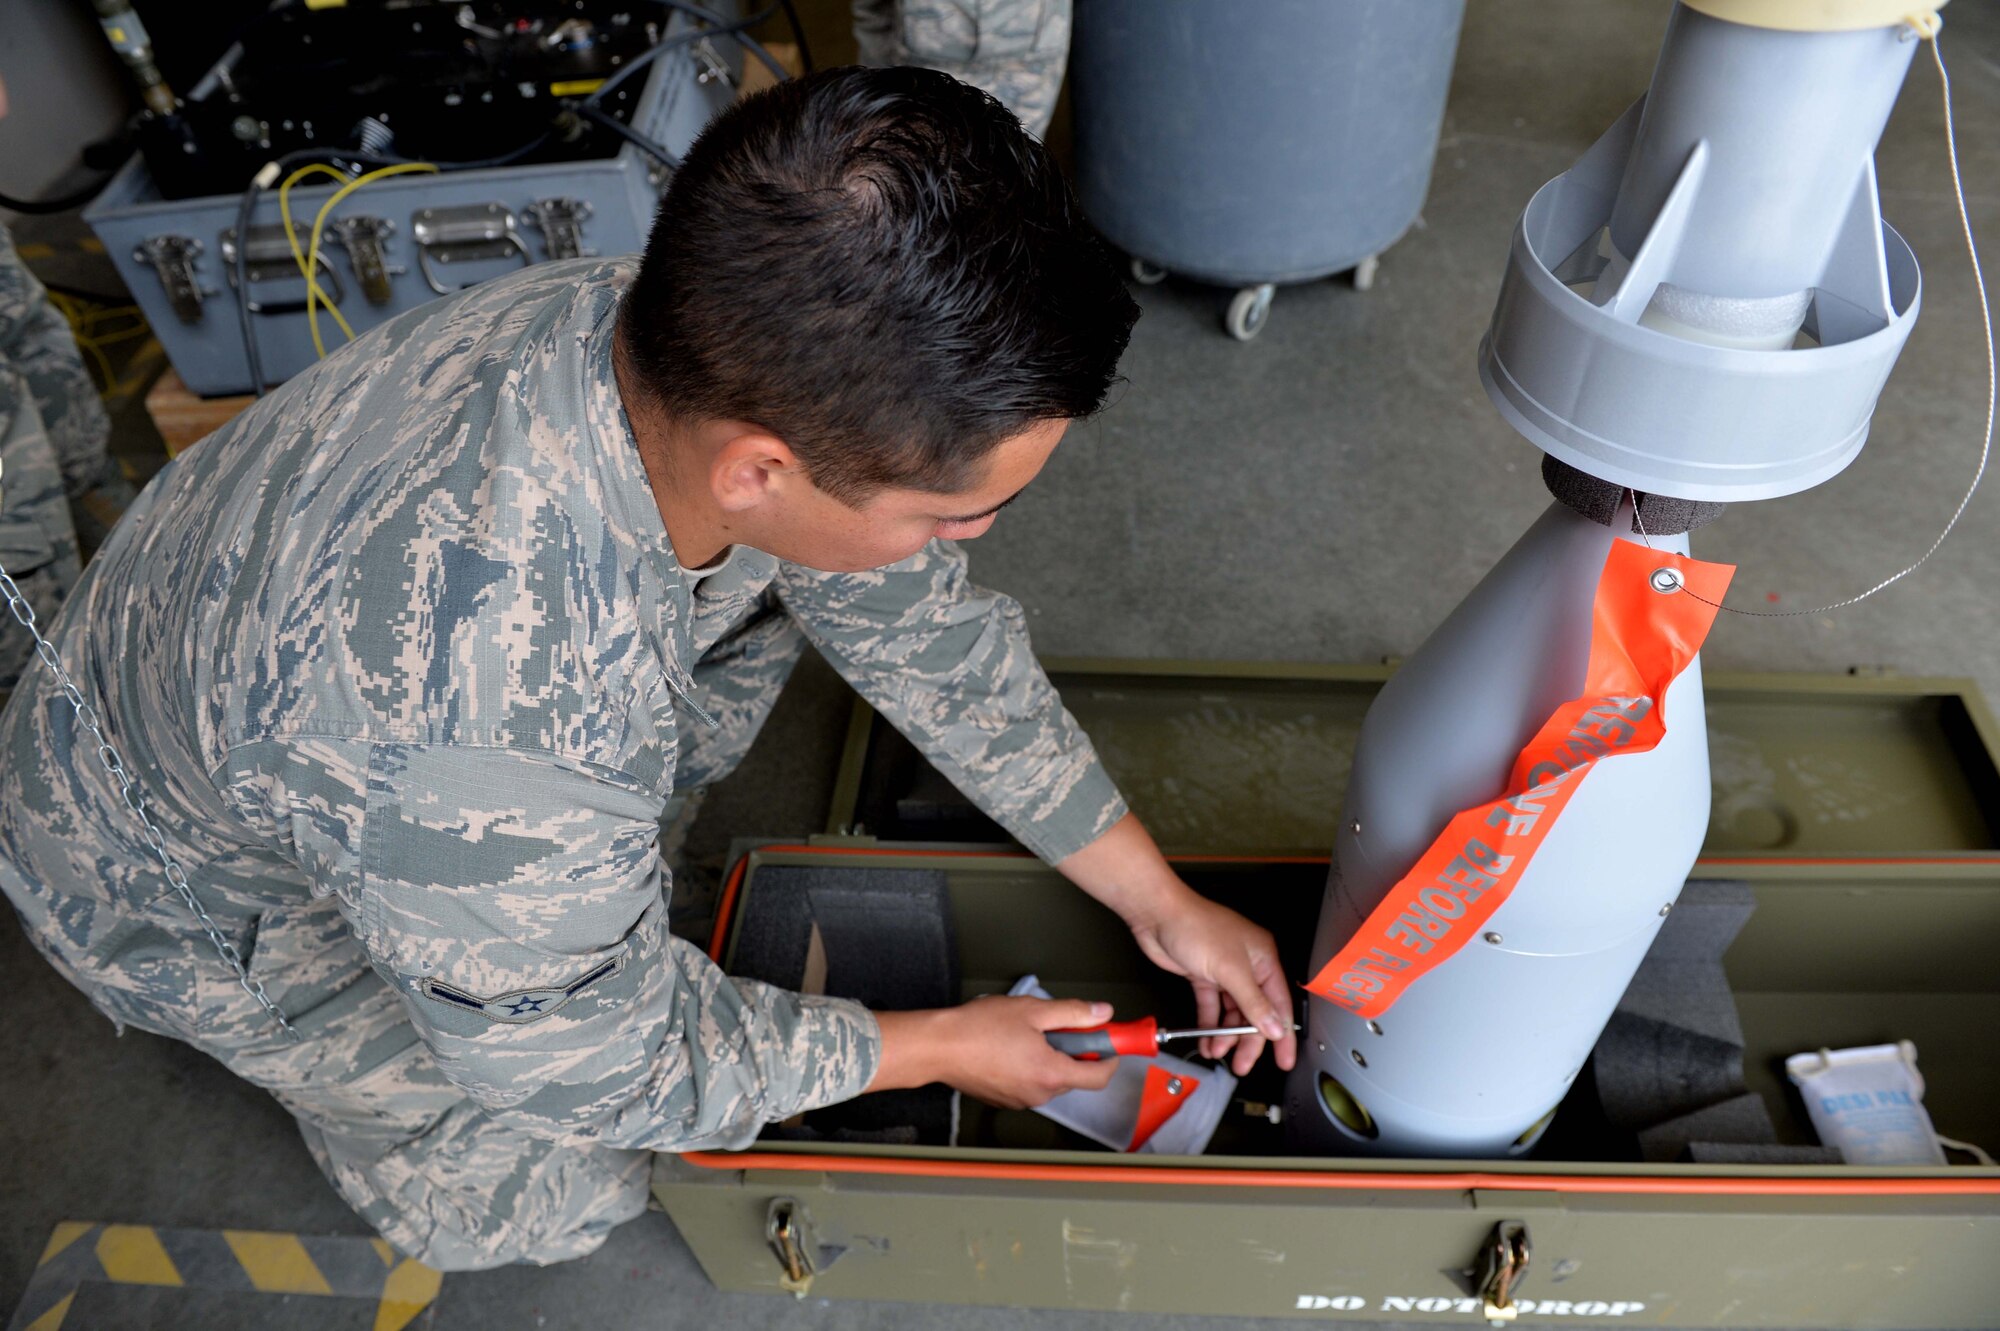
[1288,0,1920,1155]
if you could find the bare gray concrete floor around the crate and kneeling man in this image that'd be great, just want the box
[0,0,2000,1331]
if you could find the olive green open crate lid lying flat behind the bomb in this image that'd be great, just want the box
[826,660,2000,857]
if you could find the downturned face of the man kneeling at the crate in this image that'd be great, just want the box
[754,420,1070,574]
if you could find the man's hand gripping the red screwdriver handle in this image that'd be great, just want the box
[868,997,1118,1109]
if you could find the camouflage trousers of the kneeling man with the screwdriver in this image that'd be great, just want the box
[21,887,650,1271]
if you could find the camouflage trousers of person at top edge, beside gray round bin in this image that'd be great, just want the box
[854,0,1070,136]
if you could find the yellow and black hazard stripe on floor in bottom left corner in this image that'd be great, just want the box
[8,1221,444,1331]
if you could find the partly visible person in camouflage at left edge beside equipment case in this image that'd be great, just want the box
[0,226,124,693]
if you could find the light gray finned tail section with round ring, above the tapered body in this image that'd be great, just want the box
[1480,6,1920,502]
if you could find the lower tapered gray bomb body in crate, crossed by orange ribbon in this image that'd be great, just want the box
[1286,504,1710,1157]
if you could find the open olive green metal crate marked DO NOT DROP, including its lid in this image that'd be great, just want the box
[654,666,2000,1329]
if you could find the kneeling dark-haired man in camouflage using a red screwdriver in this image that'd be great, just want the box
[0,68,1292,1269]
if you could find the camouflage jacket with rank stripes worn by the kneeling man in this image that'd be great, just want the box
[0,260,1124,1149]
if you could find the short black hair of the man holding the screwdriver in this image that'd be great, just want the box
[620,66,1138,504]
